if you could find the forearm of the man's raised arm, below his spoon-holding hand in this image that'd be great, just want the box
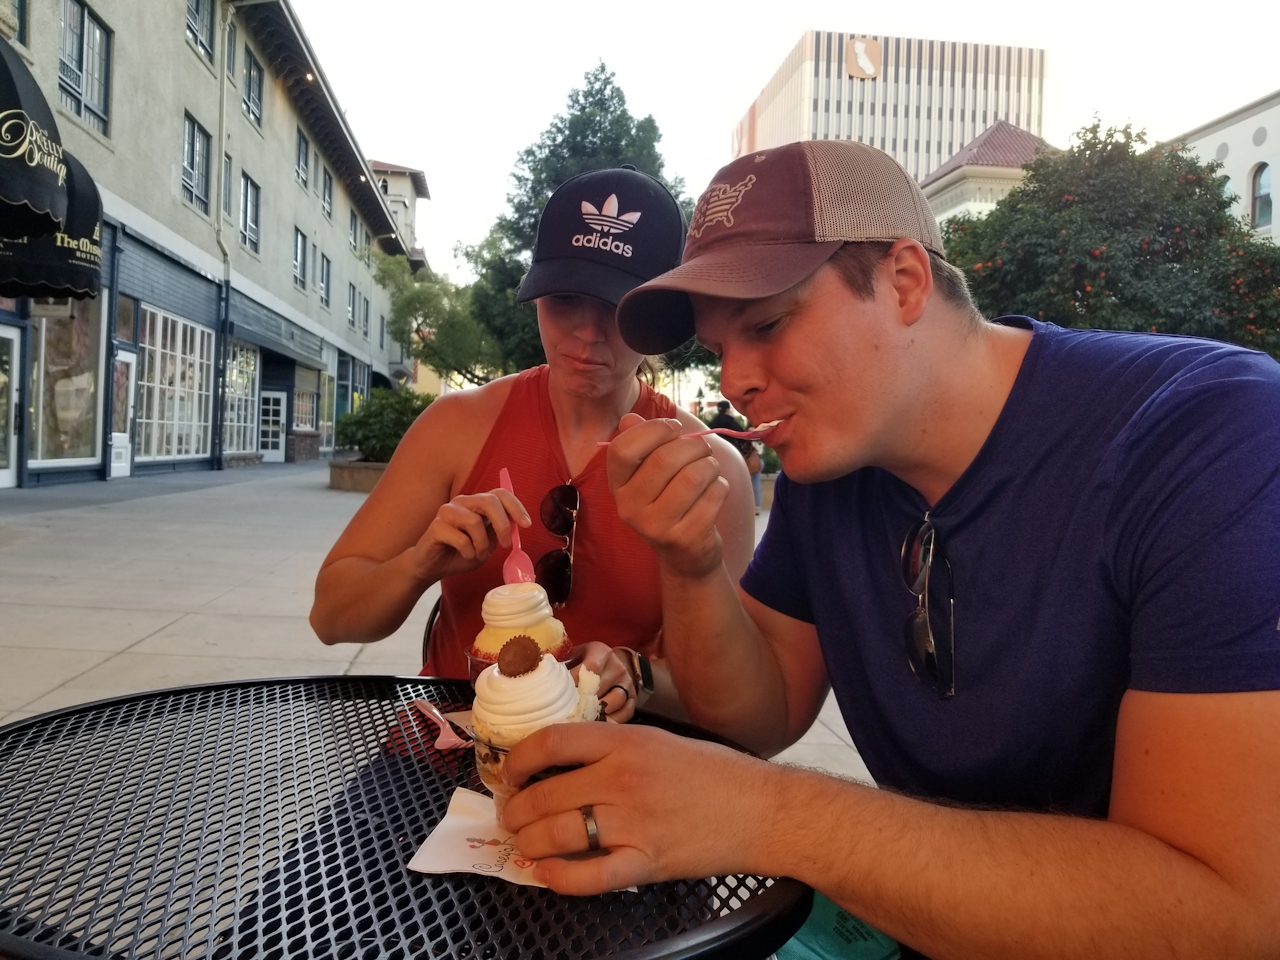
[660,566,795,756]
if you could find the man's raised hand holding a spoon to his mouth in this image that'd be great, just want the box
[608,413,730,579]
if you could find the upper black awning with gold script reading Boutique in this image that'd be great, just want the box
[0,40,67,239]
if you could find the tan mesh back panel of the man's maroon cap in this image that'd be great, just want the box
[804,140,942,253]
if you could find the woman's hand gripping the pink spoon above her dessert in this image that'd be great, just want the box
[411,490,532,584]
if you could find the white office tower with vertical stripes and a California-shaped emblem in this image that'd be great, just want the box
[732,29,1044,180]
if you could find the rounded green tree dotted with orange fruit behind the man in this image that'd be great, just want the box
[943,122,1280,357]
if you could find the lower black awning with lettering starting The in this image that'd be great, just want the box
[0,152,102,300]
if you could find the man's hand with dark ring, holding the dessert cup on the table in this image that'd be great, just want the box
[503,723,778,896]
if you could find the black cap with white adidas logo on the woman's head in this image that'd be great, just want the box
[516,165,686,305]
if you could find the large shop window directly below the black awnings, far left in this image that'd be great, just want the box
[27,299,108,466]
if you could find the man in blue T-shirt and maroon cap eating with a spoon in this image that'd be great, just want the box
[494,142,1280,957]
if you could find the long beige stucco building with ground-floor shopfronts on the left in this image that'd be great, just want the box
[0,0,428,485]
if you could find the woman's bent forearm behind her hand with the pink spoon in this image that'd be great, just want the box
[311,550,430,644]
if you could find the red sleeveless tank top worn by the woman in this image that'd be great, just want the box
[422,365,676,678]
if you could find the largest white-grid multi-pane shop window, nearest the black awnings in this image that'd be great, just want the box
[133,307,214,460]
